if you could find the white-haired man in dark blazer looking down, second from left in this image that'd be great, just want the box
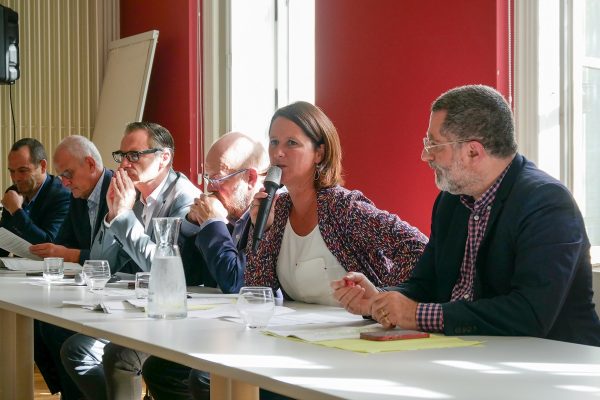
[30,135,113,400]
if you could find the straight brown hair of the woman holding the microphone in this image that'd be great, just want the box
[269,101,344,190]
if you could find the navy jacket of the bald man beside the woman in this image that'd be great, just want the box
[180,212,252,293]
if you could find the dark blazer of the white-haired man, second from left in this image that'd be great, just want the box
[56,168,113,264]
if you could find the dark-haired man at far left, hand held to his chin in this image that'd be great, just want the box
[0,138,70,257]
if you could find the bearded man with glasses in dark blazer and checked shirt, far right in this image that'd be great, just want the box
[331,85,600,346]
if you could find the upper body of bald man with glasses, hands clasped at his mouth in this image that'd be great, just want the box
[181,132,269,293]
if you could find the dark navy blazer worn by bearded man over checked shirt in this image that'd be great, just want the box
[395,154,600,346]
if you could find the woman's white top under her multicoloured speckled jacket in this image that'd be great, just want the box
[277,219,346,307]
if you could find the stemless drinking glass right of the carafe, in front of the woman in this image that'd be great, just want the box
[236,286,275,329]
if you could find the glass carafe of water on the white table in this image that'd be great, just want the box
[146,218,187,319]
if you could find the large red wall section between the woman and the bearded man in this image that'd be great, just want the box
[316,0,508,233]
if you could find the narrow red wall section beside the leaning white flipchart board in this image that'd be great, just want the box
[121,0,203,182]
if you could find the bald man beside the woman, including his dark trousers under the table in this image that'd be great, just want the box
[142,132,269,400]
